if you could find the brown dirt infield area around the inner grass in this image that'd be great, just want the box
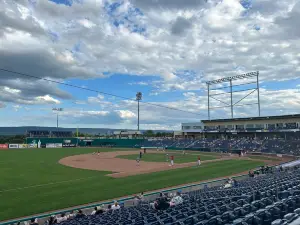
[59,151,235,178]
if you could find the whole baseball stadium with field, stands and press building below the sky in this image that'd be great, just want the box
[0,74,300,225]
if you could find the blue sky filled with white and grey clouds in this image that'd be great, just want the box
[0,0,300,130]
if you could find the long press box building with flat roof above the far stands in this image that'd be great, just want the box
[178,114,300,139]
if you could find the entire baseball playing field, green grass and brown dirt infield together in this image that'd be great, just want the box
[0,148,278,221]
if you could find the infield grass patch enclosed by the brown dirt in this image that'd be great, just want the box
[117,152,217,163]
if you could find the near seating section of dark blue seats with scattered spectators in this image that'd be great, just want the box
[21,167,300,225]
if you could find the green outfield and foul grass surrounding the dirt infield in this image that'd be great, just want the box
[0,148,262,221]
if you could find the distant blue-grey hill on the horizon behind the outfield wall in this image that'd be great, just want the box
[0,126,171,136]
